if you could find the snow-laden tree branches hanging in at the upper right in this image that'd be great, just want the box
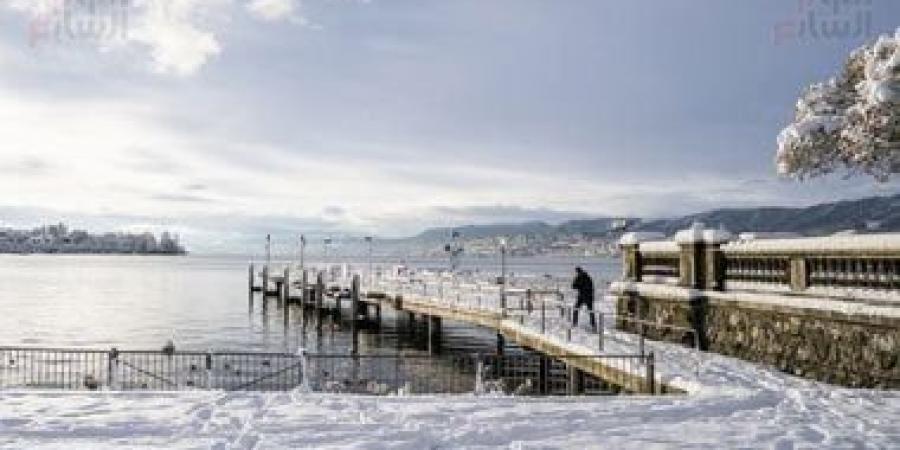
[776,28,900,181]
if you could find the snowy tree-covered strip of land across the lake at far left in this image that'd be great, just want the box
[0,223,186,255]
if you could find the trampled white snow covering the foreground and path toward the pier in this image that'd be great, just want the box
[0,280,900,449]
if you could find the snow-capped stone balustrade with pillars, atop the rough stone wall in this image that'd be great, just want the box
[622,228,900,299]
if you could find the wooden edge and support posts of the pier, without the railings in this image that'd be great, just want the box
[249,265,683,394]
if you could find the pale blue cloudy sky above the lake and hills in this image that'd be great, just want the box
[0,0,900,251]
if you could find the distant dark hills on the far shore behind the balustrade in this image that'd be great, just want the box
[412,194,900,243]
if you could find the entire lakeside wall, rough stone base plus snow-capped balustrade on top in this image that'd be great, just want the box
[612,225,900,388]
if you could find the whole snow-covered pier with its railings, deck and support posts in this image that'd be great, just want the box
[249,267,688,393]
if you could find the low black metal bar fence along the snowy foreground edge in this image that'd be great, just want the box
[0,347,654,395]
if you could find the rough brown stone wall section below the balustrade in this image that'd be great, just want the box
[617,294,900,389]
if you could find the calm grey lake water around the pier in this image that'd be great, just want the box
[0,255,621,353]
